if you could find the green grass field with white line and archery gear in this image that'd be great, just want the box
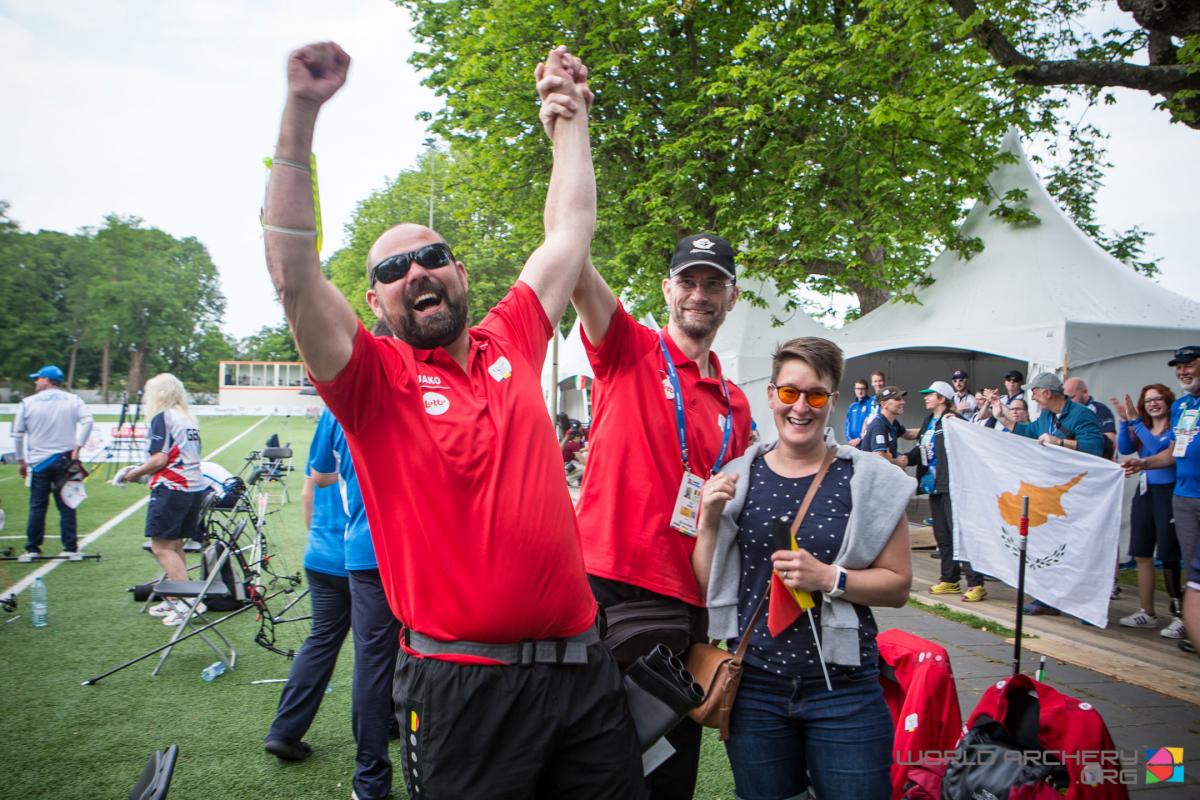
[0,417,733,800]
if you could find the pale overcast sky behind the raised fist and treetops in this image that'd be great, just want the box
[0,0,1200,337]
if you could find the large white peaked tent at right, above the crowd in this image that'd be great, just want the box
[838,131,1200,417]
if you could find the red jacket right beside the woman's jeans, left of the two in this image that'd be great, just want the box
[876,628,962,800]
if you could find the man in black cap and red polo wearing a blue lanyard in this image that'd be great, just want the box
[571,233,750,798]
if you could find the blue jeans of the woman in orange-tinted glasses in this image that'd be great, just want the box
[725,664,893,800]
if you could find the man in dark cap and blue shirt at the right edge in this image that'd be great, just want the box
[1124,344,1200,652]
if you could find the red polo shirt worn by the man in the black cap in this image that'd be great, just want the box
[576,305,750,606]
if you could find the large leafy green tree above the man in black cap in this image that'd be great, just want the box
[397,0,1156,312]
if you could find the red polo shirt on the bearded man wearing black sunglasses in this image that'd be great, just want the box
[316,282,595,661]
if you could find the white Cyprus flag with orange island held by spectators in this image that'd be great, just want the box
[943,420,1124,627]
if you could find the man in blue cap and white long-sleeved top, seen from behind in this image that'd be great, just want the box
[12,365,91,561]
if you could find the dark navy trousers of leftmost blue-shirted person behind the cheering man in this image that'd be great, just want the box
[266,570,350,740]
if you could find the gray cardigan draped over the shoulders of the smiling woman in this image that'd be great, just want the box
[708,443,917,667]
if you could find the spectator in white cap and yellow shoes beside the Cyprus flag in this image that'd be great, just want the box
[907,380,988,603]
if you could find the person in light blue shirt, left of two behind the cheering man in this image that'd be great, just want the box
[263,411,350,762]
